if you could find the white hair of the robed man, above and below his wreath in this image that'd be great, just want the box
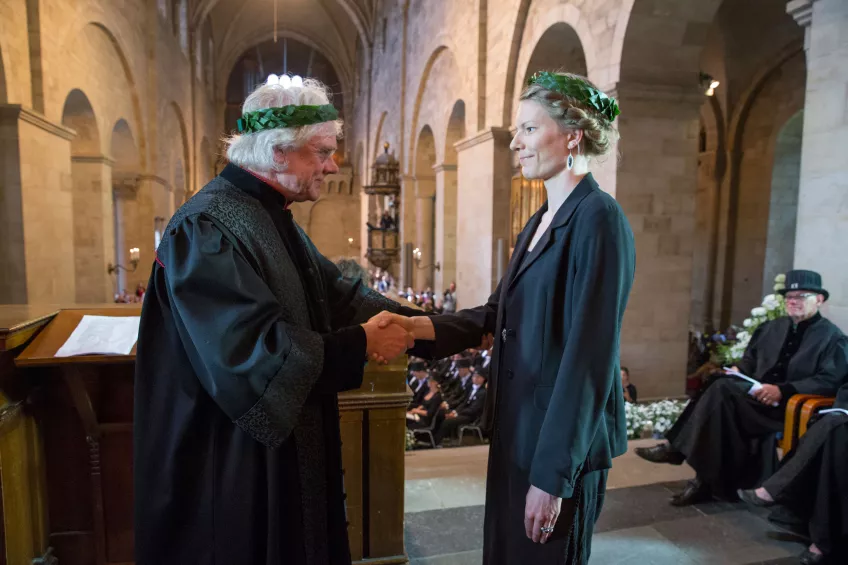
[224,79,342,172]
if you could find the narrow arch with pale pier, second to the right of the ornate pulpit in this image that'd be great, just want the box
[433,100,465,292]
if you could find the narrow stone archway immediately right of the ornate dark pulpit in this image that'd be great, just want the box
[412,125,436,292]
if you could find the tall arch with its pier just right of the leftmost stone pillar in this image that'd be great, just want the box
[62,89,109,303]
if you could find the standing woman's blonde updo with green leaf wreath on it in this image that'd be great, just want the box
[520,71,620,157]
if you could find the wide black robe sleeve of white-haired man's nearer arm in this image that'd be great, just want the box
[158,216,365,448]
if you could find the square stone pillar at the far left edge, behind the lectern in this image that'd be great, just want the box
[0,104,75,304]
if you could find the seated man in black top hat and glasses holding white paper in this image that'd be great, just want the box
[636,271,848,506]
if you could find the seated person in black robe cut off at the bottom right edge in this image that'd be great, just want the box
[739,385,848,565]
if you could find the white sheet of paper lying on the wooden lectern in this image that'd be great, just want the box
[55,316,141,357]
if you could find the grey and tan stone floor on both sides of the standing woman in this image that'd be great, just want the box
[405,441,804,565]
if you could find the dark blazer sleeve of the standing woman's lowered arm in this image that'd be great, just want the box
[530,208,635,498]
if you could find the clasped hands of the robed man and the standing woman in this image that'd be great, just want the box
[362,311,436,365]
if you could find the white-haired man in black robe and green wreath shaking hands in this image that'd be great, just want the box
[134,77,424,565]
